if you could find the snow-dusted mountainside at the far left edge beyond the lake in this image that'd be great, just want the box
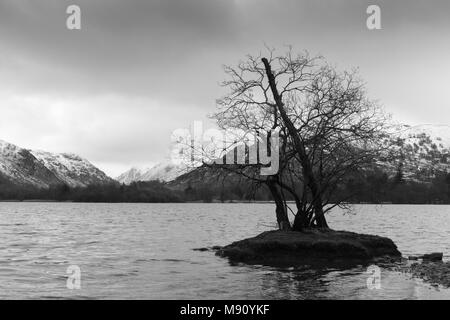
[0,140,113,188]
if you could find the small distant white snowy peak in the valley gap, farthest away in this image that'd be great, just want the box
[116,161,194,184]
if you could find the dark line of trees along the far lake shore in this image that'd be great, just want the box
[0,170,450,204]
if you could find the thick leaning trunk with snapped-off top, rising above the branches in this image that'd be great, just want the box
[261,58,328,228]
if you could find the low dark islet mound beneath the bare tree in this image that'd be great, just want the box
[216,229,401,266]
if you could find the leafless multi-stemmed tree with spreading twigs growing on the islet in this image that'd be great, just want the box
[209,48,386,230]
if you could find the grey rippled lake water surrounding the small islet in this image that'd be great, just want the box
[0,202,450,299]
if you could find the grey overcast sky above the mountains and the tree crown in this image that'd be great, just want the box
[0,0,450,176]
